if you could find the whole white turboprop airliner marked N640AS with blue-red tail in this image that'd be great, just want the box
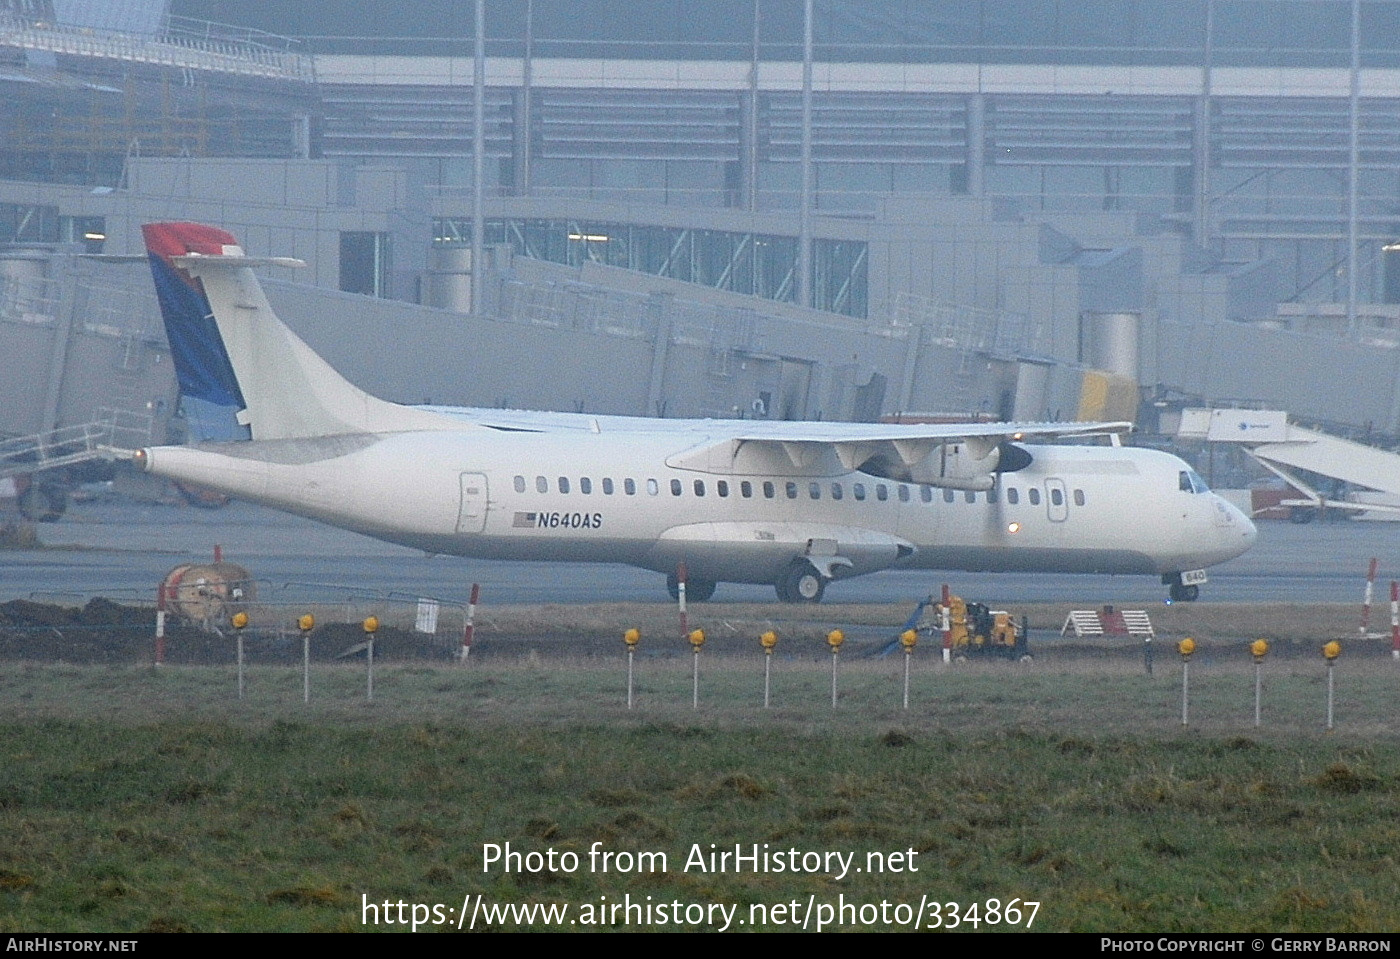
[136,223,1256,602]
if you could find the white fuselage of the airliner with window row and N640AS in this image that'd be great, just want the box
[143,430,1254,582]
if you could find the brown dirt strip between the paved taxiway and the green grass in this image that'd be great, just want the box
[0,598,1390,664]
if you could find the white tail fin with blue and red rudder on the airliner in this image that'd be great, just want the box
[141,223,462,440]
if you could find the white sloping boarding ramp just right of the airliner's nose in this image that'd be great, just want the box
[1176,409,1400,517]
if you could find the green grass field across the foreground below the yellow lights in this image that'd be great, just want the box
[0,644,1400,931]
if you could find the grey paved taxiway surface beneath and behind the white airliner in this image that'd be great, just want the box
[0,501,1400,603]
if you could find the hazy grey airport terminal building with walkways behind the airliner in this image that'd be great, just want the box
[0,0,1400,448]
